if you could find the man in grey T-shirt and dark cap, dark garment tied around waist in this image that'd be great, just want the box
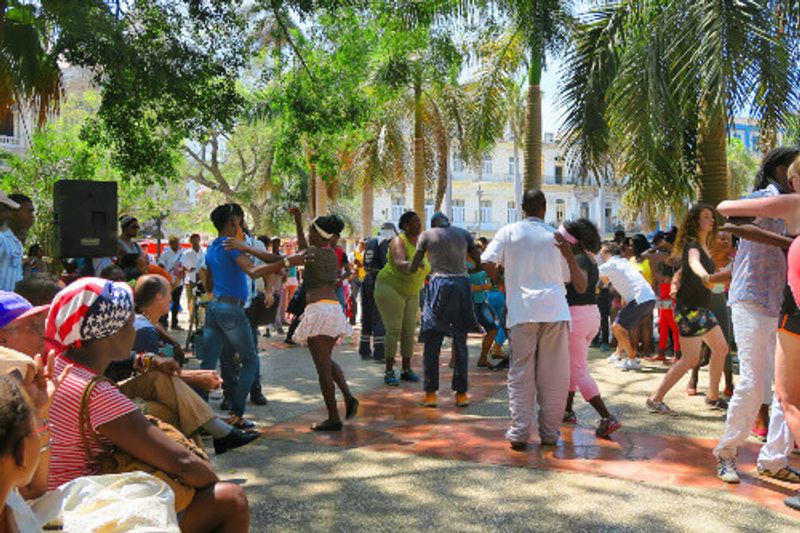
[409,212,481,407]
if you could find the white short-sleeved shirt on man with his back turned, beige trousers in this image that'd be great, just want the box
[481,217,571,328]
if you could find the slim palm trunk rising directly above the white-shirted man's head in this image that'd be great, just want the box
[525,50,542,190]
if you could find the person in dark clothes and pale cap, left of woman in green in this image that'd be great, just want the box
[358,222,397,363]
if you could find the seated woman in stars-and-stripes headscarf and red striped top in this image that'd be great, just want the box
[45,278,250,532]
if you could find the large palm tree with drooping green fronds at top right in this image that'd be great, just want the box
[560,0,798,209]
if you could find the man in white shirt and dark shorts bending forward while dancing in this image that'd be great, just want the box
[599,242,656,371]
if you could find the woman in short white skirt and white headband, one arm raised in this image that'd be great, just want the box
[289,207,358,431]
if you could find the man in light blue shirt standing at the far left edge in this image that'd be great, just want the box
[0,194,35,291]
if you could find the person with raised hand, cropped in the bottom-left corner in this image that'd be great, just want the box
[0,356,69,532]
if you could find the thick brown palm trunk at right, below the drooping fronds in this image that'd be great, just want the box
[697,104,728,206]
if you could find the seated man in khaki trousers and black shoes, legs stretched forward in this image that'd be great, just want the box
[104,274,260,455]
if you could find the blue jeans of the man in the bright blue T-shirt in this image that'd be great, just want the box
[200,300,259,416]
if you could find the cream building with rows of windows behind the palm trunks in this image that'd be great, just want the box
[374,133,636,237]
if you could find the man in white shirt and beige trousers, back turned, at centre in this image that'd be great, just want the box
[481,189,587,450]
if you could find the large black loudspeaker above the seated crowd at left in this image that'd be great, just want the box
[53,180,117,257]
